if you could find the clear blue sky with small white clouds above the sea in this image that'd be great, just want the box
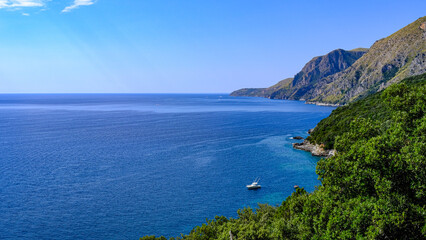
[0,0,426,93]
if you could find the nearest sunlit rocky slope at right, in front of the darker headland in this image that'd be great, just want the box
[307,17,426,104]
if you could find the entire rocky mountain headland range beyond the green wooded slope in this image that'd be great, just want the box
[231,17,426,105]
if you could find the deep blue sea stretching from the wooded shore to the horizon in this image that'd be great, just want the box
[0,94,333,239]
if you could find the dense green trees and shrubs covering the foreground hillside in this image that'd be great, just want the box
[142,74,426,240]
